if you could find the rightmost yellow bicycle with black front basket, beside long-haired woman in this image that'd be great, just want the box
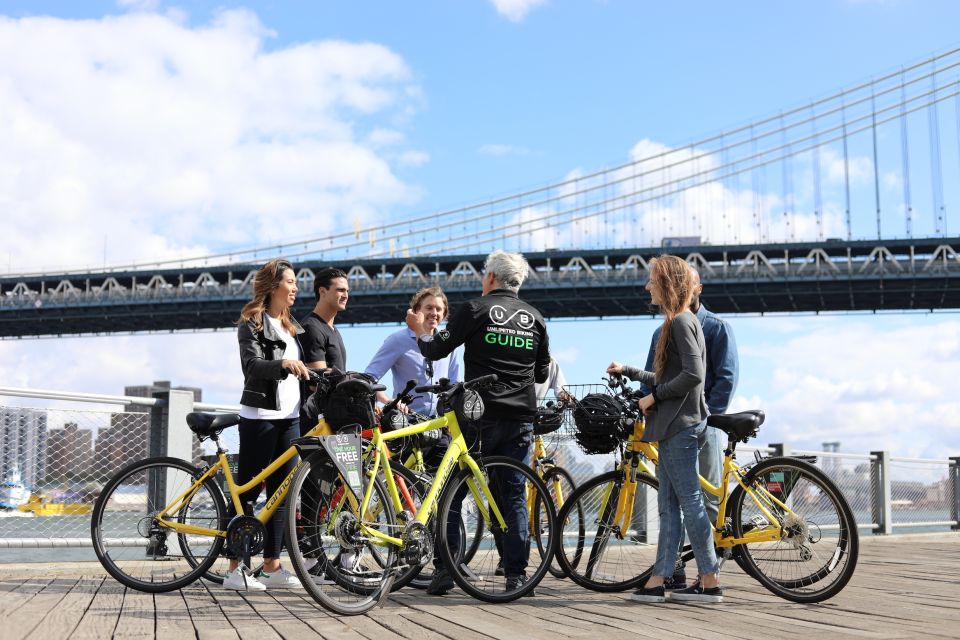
[557,378,859,602]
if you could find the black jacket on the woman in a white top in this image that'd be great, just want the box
[237,313,303,411]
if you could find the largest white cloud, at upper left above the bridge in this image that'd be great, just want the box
[0,8,428,271]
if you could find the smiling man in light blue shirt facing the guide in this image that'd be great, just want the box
[364,287,460,416]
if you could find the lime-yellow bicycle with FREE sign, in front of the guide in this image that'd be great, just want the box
[287,375,556,615]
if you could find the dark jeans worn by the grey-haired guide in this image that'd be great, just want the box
[436,418,533,576]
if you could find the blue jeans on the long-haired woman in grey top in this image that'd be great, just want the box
[653,422,719,578]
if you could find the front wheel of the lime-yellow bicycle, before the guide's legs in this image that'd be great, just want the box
[437,456,557,602]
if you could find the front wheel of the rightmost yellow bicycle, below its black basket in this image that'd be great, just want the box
[556,470,660,593]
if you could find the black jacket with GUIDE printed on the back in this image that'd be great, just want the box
[417,289,550,422]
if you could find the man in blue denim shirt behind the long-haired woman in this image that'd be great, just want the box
[607,266,740,589]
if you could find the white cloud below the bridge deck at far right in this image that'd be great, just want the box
[731,316,960,457]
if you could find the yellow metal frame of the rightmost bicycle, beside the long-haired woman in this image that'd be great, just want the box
[601,419,804,549]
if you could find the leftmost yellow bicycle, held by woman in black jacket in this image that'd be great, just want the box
[90,373,420,593]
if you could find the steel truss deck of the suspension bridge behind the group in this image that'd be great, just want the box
[0,238,960,338]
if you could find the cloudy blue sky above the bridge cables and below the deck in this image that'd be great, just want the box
[0,0,960,456]
